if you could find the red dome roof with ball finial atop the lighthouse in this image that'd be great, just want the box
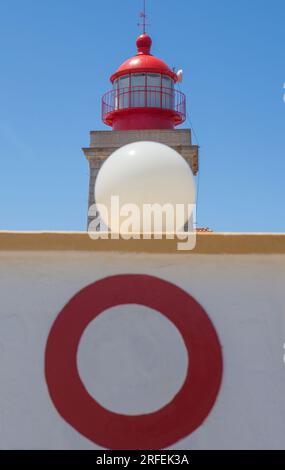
[111,34,177,82]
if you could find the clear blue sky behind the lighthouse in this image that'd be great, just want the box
[0,0,285,232]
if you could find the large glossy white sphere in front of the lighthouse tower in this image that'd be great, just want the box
[95,142,196,233]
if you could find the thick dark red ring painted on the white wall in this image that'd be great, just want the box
[45,275,223,450]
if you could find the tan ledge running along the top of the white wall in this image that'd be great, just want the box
[0,231,285,255]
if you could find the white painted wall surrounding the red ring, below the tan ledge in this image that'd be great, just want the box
[0,252,285,450]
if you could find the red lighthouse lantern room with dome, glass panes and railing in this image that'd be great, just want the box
[102,33,186,131]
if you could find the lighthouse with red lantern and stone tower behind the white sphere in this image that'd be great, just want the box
[83,25,198,222]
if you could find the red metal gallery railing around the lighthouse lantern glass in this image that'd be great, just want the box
[102,86,186,122]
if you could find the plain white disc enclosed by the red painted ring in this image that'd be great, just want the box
[77,305,188,416]
